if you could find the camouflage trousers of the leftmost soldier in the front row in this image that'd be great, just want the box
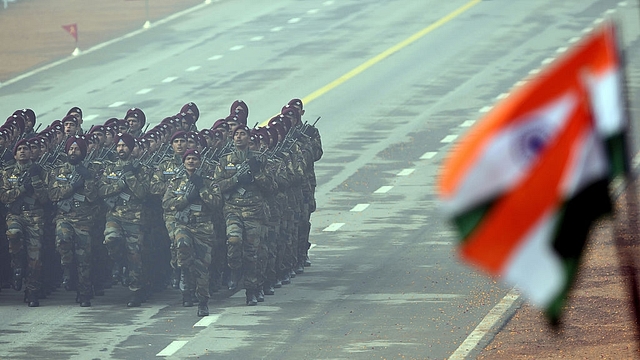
[7,210,43,291]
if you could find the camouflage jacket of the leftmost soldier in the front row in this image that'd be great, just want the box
[0,161,49,215]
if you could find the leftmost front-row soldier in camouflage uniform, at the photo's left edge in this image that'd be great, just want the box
[0,139,48,307]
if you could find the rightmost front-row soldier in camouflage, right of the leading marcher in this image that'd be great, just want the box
[214,126,275,305]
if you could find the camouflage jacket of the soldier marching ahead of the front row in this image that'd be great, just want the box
[162,171,222,224]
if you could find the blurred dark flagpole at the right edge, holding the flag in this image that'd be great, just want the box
[614,28,640,351]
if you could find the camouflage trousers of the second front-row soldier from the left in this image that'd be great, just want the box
[56,219,92,295]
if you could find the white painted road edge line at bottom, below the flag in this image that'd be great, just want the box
[449,288,520,360]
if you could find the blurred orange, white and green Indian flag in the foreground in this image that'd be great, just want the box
[438,25,626,321]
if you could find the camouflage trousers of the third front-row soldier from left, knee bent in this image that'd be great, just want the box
[104,215,145,291]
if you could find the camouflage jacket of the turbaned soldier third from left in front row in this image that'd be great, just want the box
[98,160,149,223]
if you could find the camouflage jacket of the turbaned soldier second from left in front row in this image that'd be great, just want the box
[48,162,98,219]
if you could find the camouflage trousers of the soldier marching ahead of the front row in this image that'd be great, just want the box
[174,222,214,300]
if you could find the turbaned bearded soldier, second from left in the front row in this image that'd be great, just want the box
[49,136,98,307]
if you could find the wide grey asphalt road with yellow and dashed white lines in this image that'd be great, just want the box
[0,0,638,359]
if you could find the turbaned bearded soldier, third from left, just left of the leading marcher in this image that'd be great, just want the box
[98,133,149,307]
